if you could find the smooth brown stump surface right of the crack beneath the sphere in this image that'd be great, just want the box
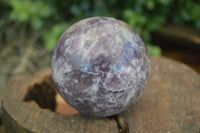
[121,58,200,133]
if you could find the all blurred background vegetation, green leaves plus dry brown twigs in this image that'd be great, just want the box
[0,0,200,90]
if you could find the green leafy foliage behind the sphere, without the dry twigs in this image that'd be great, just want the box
[7,0,200,55]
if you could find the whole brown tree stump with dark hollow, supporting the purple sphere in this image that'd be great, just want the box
[2,57,200,133]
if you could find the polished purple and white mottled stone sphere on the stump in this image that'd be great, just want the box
[51,17,150,117]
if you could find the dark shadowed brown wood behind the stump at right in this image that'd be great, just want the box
[152,24,200,74]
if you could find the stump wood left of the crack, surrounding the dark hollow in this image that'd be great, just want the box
[2,69,118,133]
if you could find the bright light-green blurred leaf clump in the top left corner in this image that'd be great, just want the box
[10,0,53,29]
